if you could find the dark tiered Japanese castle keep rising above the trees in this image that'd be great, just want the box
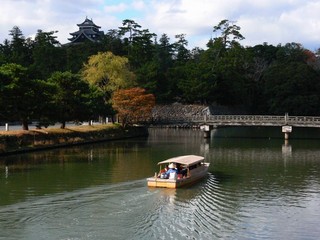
[68,17,104,44]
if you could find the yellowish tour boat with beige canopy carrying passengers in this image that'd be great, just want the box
[147,155,210,188]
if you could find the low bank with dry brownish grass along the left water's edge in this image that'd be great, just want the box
[0,124,148,155]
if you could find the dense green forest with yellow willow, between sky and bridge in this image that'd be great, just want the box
[0,19,320,128]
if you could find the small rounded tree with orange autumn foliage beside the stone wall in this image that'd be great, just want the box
[112,87,155,127]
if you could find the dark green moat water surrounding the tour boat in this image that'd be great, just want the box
[0,129,320,239]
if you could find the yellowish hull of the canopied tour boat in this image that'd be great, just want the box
[147,163,209,188]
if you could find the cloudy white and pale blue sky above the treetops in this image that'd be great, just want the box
[0,0,320,51]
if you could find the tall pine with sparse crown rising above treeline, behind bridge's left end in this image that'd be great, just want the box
[203,20,249,105]
